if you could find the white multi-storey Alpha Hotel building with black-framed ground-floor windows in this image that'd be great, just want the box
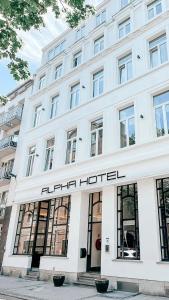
[3,0,169,295]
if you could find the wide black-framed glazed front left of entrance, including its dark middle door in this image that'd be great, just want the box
[14,196,70,259]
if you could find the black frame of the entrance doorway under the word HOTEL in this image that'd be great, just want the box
[86,192,102,272]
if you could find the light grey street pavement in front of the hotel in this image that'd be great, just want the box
[0,276,169,300]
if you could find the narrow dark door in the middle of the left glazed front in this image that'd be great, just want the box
[31,201,49,268]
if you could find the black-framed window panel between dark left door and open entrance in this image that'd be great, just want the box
[45,196,70,256]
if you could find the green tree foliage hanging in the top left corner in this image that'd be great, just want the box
[0,0,94,84]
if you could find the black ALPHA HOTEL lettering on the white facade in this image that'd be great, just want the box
[41,171,126,195]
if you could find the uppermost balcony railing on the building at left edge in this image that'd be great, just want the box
[0,105,23,130]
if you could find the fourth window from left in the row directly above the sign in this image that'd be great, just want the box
[90,118,103,156]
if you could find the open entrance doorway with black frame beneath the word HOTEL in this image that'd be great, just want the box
[87,192,102,272]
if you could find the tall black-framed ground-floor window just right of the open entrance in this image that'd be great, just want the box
[117,183,140,259]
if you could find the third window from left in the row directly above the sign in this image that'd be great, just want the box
[65,129,77,164]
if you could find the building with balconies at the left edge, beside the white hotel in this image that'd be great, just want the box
[0,80,32,269]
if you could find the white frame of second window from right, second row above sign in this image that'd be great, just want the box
[118,53,133,84]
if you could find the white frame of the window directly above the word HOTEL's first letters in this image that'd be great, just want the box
[90,117,103,157]
